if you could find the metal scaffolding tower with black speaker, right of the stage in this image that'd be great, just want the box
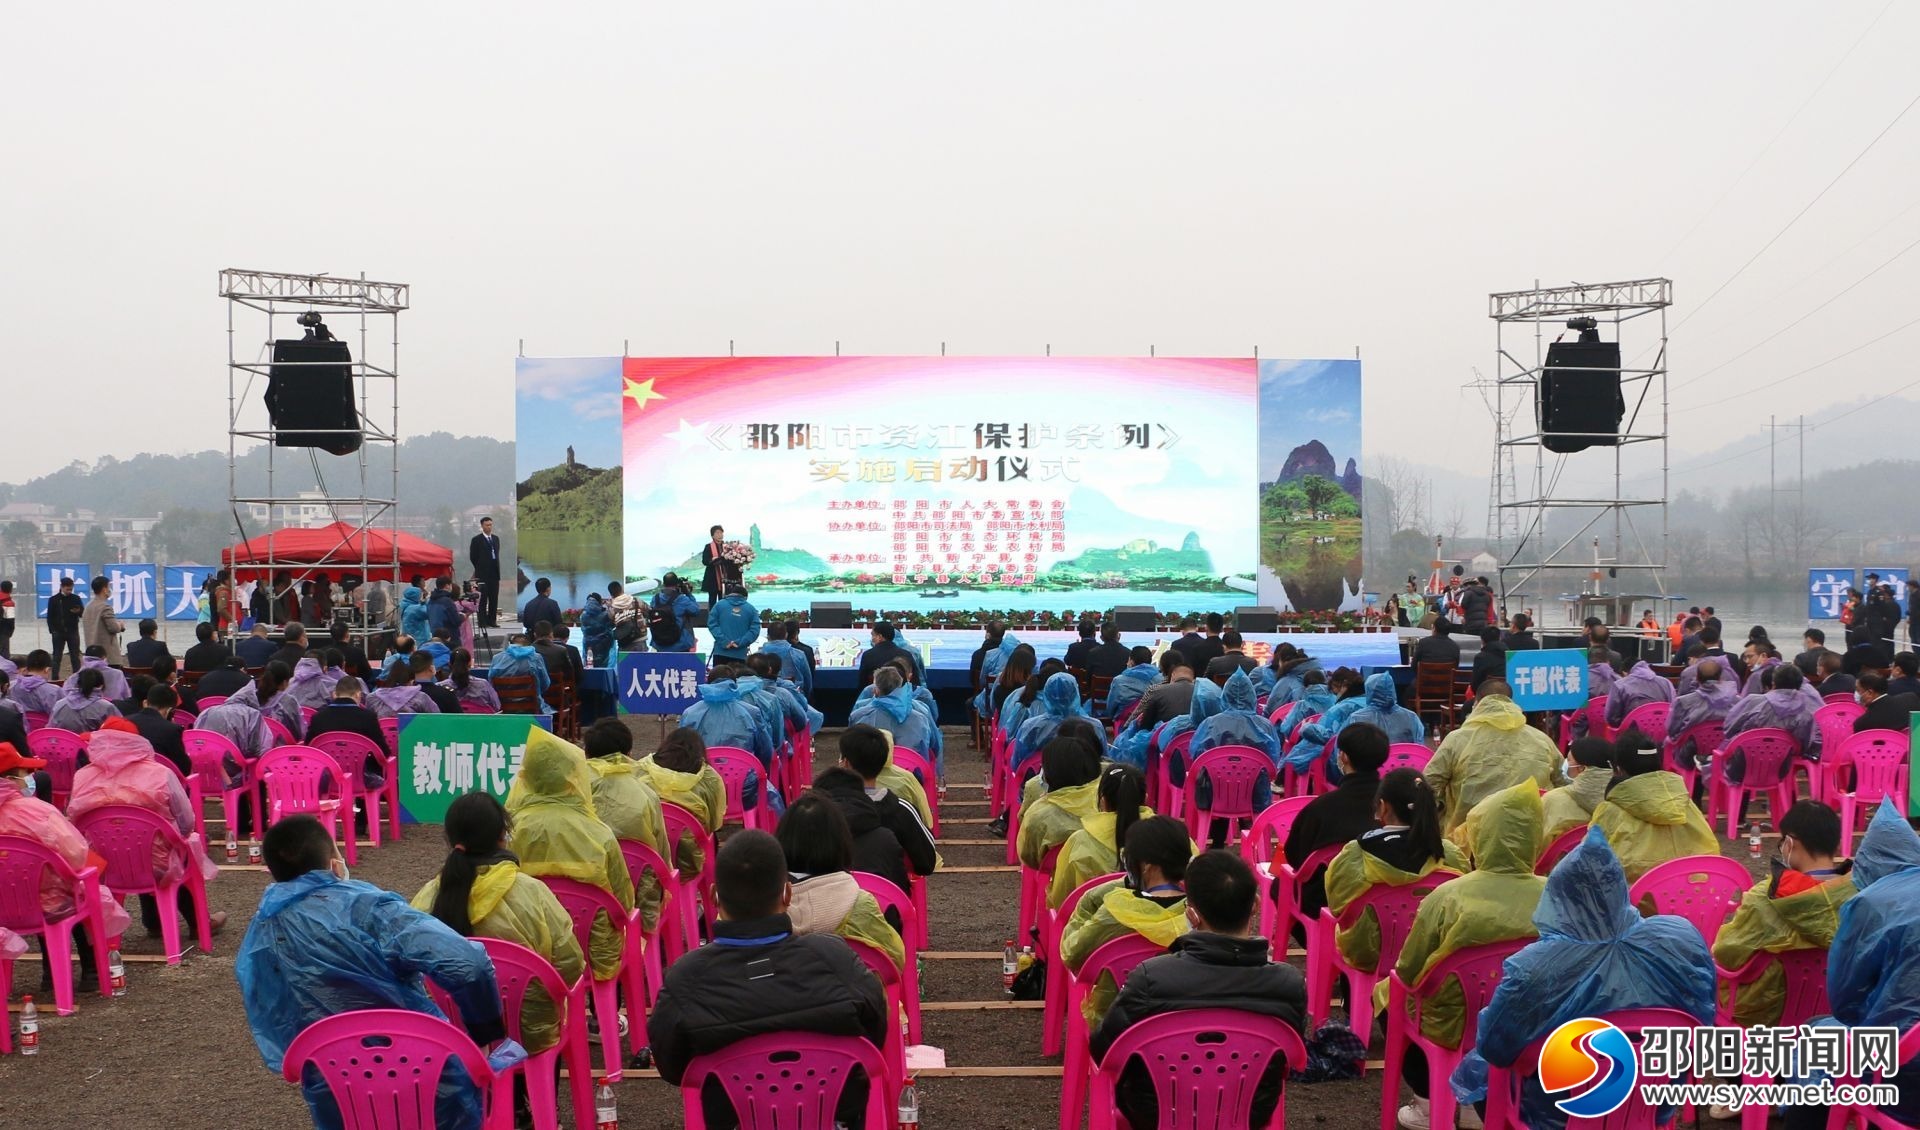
[1488,278,1672,629]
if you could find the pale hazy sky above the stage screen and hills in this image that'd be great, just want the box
[0,0,1920,489]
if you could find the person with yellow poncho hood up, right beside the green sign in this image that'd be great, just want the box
[507,725,634,980]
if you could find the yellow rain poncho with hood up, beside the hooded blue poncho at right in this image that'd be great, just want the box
[1373,781,1548,1048]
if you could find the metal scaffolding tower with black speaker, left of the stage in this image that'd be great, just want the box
[221,269,409,635]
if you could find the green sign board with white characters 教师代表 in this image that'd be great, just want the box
[399,714,553,823]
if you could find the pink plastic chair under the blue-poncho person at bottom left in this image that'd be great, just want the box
[280,1009,513,1130]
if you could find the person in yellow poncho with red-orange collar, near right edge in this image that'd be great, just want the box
[1713,800,1857,1028]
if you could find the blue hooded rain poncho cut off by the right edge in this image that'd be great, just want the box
[1826,804,1920,1032]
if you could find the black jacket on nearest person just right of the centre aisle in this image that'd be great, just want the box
[1089,930,1308,1126]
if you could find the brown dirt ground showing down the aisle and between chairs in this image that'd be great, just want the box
[0,725,1745,1130]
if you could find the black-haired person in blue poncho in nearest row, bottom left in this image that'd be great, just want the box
[234,815,526,1130]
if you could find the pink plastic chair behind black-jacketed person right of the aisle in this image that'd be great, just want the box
[1087,1009,1308,1130]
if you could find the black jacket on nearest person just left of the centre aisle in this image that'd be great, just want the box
[647,913,891,1126]
